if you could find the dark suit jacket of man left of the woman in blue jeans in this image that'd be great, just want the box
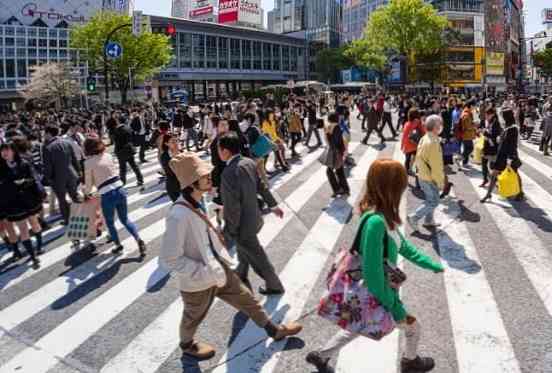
[42,137,81,186]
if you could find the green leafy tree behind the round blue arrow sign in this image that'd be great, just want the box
[71,12,172,103]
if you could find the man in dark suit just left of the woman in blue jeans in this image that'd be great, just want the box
[43,126,82,224]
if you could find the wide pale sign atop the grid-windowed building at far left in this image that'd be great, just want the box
[0,0,127,27]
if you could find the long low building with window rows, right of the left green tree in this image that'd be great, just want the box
[151,16,307,101]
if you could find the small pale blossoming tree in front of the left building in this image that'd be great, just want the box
[22,62,80,109]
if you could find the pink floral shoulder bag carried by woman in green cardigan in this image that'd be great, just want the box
[318,214,406,340]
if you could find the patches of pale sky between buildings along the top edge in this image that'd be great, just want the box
[135,0,552,36]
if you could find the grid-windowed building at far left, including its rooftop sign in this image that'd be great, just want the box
[0,0,134,100]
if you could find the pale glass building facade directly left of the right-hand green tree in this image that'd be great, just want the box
[342,0,389,43]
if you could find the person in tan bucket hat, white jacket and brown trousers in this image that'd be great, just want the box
[159,152,303,360]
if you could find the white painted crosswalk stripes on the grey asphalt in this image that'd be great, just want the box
[0,143,552,373]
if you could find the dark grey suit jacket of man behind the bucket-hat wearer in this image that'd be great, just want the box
[220,155,278,239]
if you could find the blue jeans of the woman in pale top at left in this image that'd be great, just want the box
[102,188,140,245]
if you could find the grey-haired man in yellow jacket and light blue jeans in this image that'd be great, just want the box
[407,115,445,232]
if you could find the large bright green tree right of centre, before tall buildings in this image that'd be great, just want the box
[351,0,448,81]
